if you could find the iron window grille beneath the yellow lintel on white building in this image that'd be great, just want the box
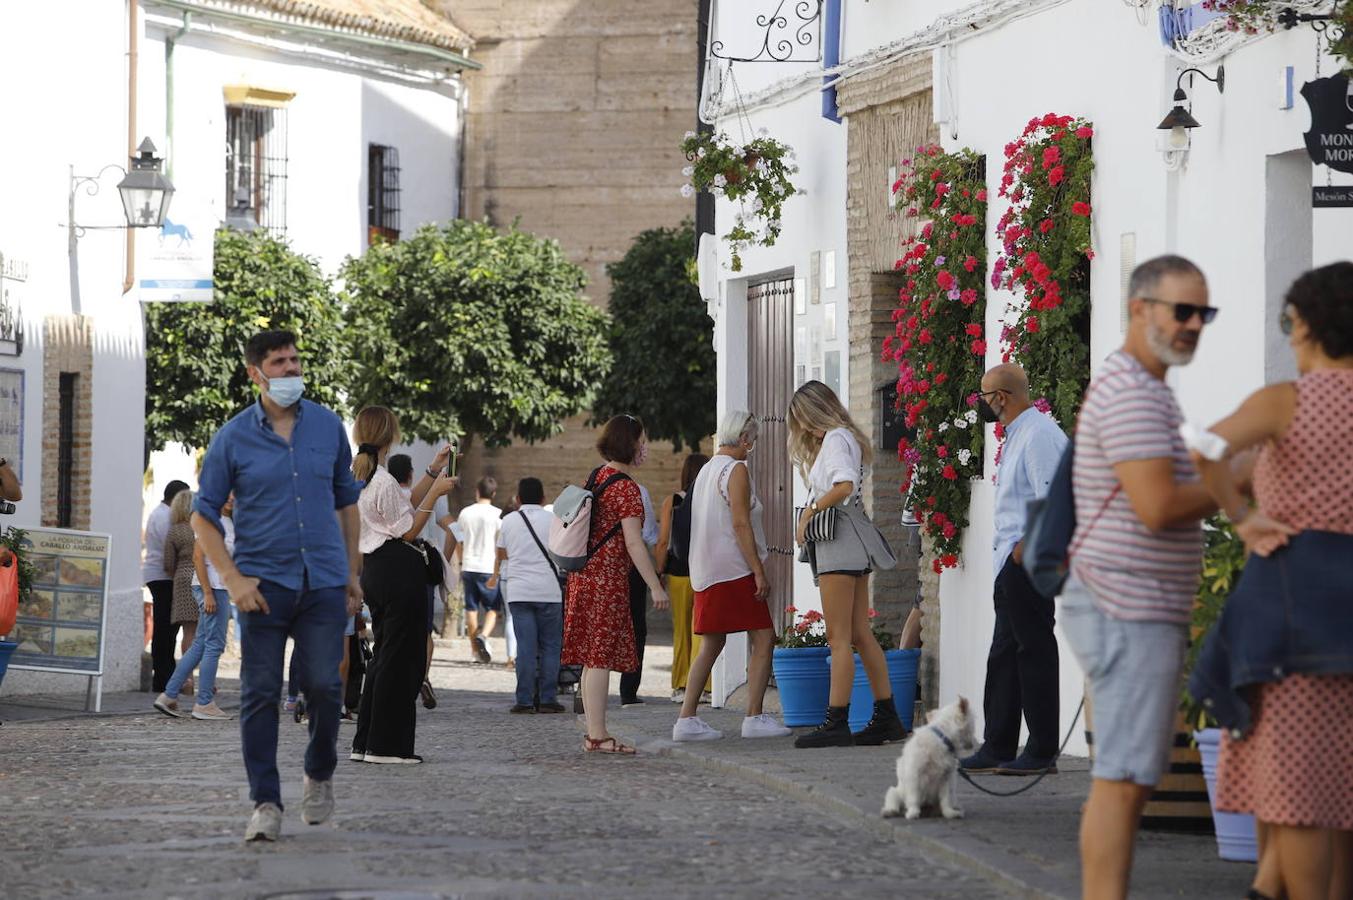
[226,106,287,235]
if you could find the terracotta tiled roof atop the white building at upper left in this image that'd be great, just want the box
[210,0,475,53]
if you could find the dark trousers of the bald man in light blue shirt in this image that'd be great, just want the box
[982,559,1058,762]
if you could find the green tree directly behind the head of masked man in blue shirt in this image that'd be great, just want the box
[145,224,345,451]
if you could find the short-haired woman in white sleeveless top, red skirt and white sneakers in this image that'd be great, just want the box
[672,410,790,740]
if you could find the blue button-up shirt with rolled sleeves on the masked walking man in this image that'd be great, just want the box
[193,399,359,590]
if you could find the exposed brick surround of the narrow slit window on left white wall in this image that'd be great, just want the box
[42,315,93,531]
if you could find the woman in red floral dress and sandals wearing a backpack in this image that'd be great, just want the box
[561,415,667,755]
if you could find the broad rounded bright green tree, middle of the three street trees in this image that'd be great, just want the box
[342,221,610,445]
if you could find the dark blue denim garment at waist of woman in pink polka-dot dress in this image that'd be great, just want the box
[1188,531,1353,738]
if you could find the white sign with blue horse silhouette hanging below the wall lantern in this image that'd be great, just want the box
[137,198,216,303]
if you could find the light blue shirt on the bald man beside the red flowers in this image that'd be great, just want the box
[992,406,1066,574]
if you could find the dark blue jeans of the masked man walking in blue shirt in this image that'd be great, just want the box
[239,581,348,807]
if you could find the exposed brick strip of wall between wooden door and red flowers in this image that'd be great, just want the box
[838,54,939,708]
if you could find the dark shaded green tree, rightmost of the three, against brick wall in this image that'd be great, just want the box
[593,222,716,451]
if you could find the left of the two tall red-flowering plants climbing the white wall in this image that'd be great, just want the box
[882,145,986,572]
